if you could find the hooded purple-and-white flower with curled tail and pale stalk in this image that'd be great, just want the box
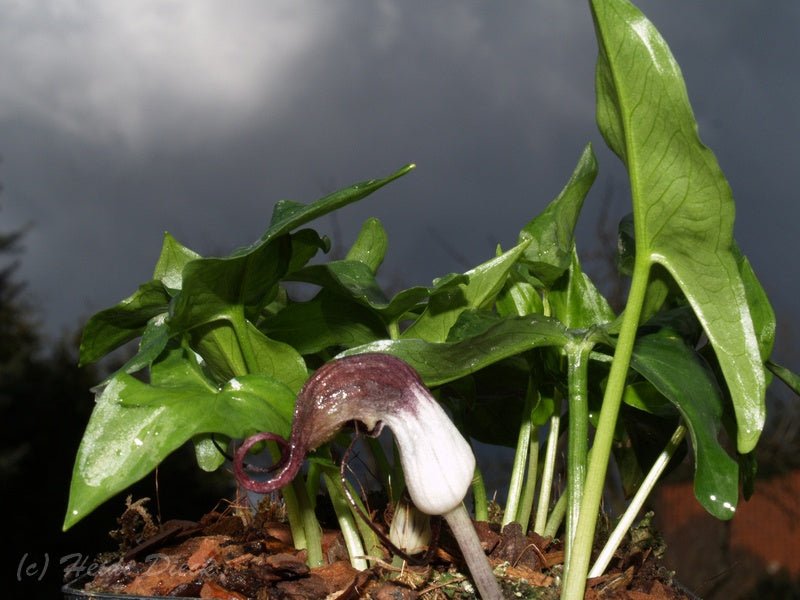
[234,353,502,598]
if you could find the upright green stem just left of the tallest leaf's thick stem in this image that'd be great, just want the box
[564,341,592,569]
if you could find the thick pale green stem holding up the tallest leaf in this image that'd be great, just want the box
[561,253,650,600]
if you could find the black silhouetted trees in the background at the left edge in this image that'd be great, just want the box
[0,227,231,599]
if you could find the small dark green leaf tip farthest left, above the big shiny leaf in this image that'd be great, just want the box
[80,280,170,365]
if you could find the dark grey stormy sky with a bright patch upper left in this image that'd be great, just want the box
[0,0,800,366]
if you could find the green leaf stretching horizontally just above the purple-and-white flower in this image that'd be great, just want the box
[338,315,571,386]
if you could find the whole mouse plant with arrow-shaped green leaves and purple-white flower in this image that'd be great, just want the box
[64,0,800,599]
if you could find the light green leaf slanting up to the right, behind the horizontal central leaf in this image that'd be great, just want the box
[402,241,528,342]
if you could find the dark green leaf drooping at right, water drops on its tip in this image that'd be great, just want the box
[631,334,739,519]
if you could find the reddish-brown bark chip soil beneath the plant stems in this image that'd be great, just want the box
[70,502,693,600]
